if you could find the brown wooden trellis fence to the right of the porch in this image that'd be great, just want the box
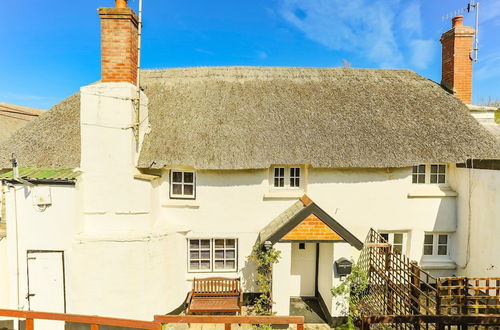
[359,229,500,329]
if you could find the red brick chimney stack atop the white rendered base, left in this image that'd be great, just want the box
[98,0,138,85]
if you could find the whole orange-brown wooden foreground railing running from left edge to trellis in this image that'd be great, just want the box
[0,309,304,330]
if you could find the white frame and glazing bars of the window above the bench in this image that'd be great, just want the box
[187,237,239,273]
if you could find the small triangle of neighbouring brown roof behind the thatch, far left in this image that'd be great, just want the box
[0,102,43,143]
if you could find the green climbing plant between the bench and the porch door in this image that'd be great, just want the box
[248,242,281,315]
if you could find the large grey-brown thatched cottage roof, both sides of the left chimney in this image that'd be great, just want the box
[0,67,500,169]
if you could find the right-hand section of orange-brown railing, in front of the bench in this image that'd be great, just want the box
[155,315,304,330]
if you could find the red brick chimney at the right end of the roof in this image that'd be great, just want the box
[440,16,474,104]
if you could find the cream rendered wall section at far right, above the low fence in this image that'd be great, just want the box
[453,168,500,277]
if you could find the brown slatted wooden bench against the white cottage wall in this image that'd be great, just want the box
[186,277,243,314]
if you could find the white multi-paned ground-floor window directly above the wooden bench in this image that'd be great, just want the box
[188,238,238,272]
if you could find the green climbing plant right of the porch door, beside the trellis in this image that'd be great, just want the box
[332,263,368,329]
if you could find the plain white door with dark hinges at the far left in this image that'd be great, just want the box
[27,251,65,330]
